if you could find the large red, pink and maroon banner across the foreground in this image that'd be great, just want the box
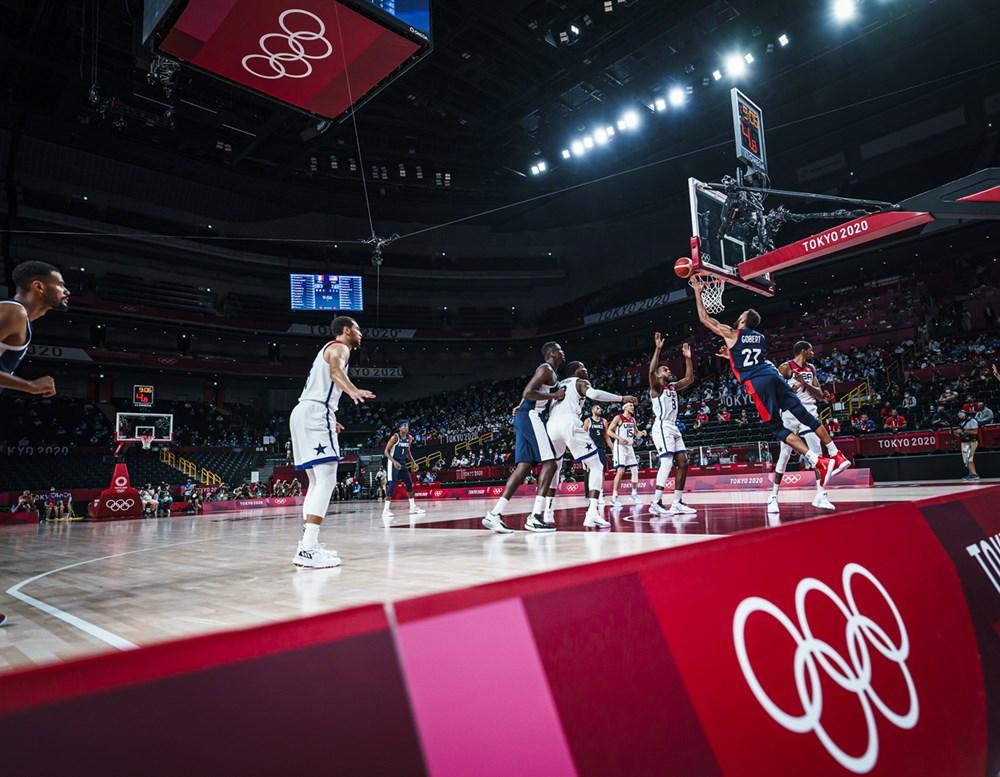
[0,488,1000,777]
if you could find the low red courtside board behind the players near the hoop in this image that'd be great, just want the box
[406,467,873,499]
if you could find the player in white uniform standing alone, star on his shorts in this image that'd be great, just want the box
[289,316,375,569]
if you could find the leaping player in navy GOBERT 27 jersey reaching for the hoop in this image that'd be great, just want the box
[688,277,851,488]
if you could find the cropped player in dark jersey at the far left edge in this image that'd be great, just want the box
[0,261,69,397]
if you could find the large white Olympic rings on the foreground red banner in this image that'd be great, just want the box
[733,563,920,774]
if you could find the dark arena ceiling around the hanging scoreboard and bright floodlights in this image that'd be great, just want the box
[0,0,1000,230]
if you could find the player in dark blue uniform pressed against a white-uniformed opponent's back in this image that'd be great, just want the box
[483,342,566,534]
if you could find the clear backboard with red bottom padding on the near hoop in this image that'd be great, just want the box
[688,178,775,297]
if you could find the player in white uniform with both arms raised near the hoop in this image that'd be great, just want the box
[649,332,696,515]
